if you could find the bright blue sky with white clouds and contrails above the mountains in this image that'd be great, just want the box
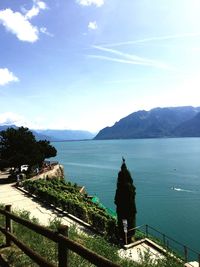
[0,0,200,132]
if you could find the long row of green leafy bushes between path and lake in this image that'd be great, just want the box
[23,178,117,240]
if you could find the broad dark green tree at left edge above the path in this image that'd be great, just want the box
[0,127,56,170]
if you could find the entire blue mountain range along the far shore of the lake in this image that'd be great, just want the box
[0,106,200,141]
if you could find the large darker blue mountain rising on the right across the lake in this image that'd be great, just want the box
[94,106,200,140]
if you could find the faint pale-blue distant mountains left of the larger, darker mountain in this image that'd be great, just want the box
[0,125,95,141]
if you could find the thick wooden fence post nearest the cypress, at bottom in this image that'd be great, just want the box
[58,225,68,267]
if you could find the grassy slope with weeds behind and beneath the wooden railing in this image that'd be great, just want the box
[0,204,182,267]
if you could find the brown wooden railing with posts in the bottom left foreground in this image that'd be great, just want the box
[0,205,120,267]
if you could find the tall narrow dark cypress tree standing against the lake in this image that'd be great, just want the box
[115,158,137,243]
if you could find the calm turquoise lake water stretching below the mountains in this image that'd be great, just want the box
[53,138,200,256]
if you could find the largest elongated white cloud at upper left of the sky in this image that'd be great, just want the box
[0,9,39,42]
